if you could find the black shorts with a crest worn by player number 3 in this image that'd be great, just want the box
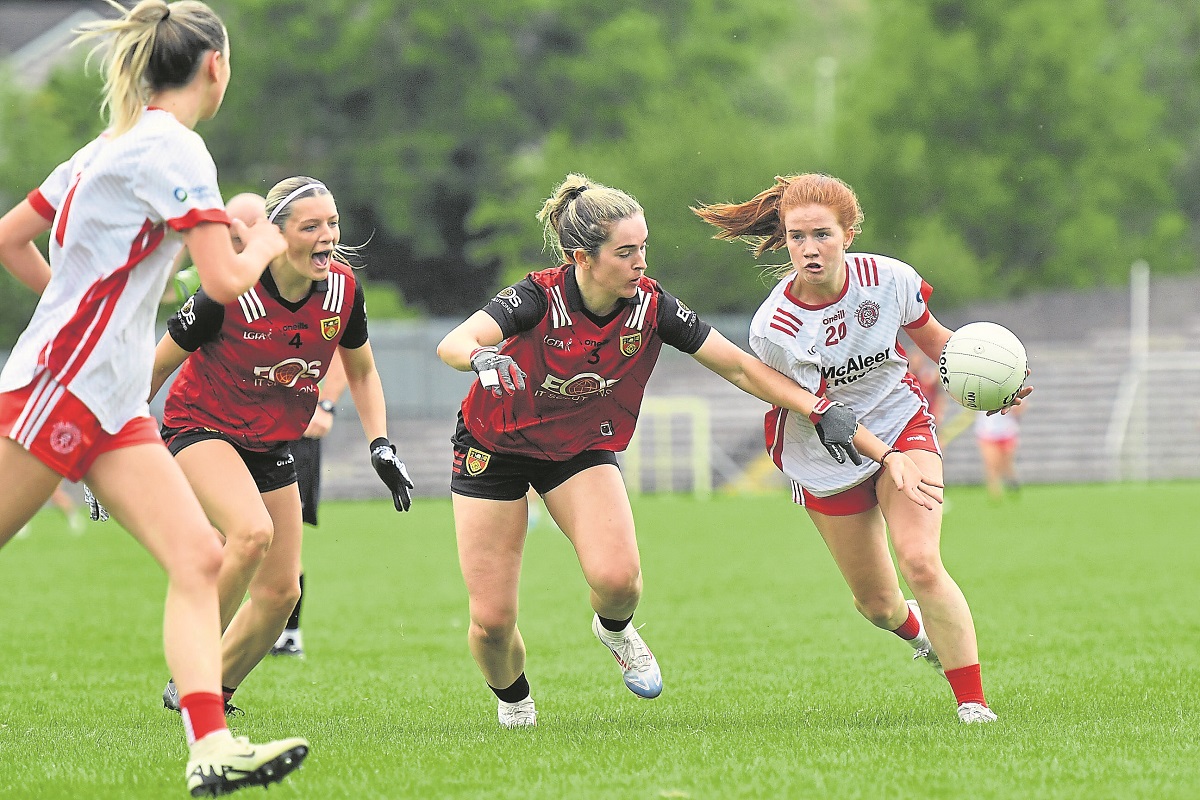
[450,416,617,500]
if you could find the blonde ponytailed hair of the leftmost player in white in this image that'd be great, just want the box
[74,0,228,137]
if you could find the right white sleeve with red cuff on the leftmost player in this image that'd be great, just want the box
[134,131,229,230]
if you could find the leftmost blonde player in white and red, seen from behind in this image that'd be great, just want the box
[0,0,308,796]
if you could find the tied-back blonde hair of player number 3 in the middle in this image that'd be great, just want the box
[538,173,643,264]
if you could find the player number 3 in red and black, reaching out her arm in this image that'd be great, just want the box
[438,175,941,728]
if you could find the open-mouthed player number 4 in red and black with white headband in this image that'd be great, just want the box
[152,178,413,708]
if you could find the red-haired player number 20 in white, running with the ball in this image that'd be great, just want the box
[694,174,1031,723]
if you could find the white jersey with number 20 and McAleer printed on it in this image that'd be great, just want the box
[750,253,936,497]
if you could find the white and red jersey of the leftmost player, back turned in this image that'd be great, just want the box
[0,109,229,433]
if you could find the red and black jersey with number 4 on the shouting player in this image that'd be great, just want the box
[163,261,367,450]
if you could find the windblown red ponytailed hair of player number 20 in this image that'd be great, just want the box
[691,173,863,258]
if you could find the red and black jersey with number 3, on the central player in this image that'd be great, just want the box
[453,265,712,461]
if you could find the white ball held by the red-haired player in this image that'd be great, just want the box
[937,323,1028,411]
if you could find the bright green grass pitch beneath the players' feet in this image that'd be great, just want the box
[0,483,1200,800]
